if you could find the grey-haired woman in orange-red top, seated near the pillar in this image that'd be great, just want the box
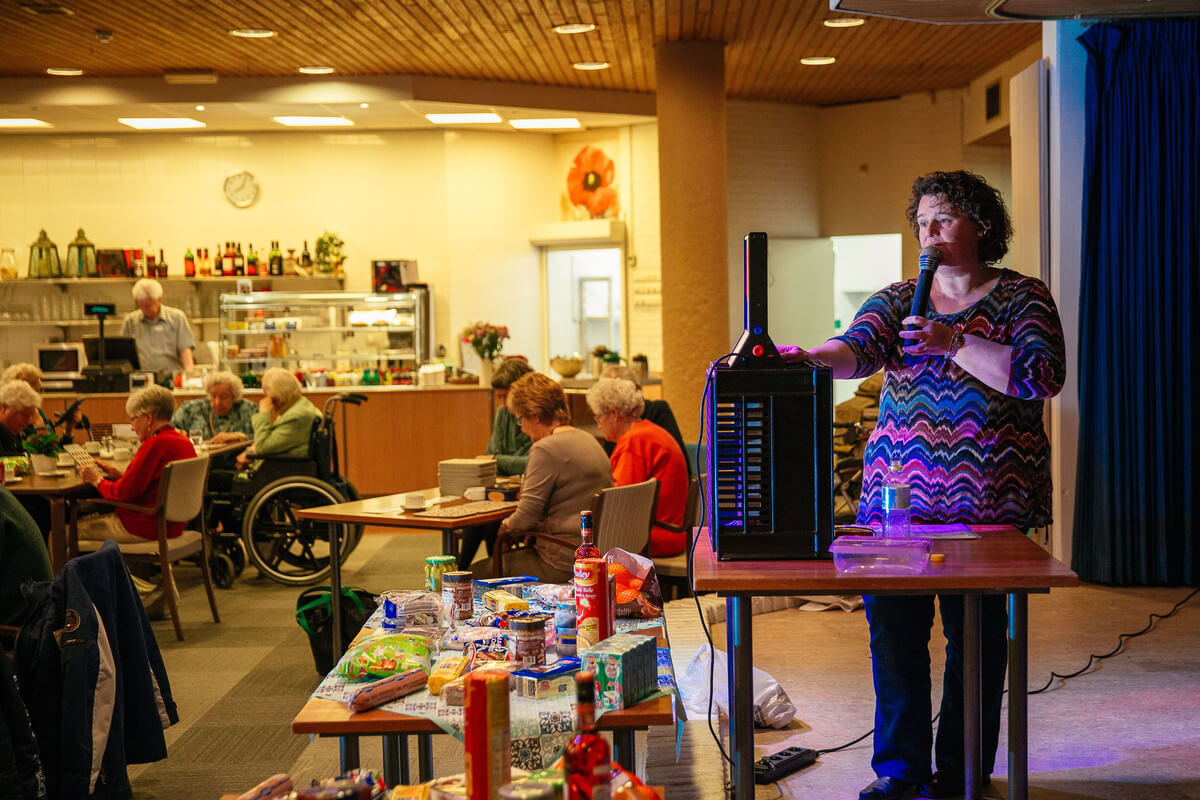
[588,378,688,558]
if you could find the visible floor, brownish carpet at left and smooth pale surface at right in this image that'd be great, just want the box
[131,533,1200,800]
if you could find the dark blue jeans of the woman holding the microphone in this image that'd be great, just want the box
[863,595,1008,782]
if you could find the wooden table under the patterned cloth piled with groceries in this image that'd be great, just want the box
[292,628,674,783]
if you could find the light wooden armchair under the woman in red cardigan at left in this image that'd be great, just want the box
[68,456,221,642]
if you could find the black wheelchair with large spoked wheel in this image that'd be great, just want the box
[205,392,367,589]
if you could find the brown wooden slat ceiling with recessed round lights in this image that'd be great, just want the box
[0,0,1040,106]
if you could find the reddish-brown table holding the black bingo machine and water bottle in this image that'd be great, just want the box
[692,525,1079,800]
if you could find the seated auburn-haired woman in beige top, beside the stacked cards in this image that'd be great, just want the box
[470,372,612,583]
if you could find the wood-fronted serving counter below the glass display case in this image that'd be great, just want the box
[42,385,492,495]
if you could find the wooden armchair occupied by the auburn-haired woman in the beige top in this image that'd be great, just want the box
[492,477,659,578]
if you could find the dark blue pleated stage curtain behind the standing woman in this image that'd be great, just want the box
[1072,19,1200,585]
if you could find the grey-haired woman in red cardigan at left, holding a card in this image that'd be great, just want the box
[79,386,196,542]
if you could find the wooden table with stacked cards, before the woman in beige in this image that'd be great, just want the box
[295,487,516,656]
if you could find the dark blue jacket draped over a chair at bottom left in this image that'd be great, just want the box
[16,541,179,800]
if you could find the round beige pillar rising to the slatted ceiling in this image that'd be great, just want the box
[654,42,732,441]
